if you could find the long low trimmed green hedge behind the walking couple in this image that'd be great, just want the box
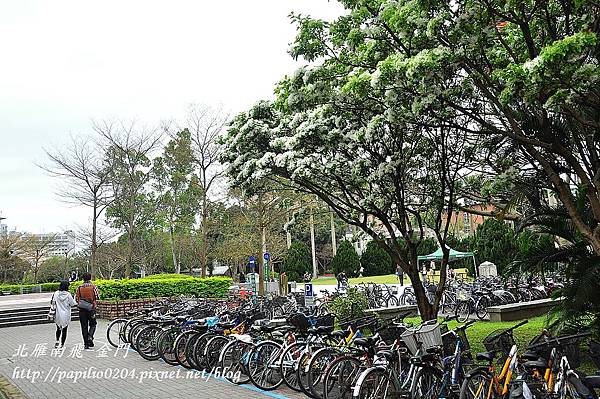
[69,276,231,300]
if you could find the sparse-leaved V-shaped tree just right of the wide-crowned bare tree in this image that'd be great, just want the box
[94,122,162,277]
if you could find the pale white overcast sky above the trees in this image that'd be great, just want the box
[0,0,341,232]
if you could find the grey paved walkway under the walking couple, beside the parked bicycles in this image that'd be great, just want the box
[0,320,305,399]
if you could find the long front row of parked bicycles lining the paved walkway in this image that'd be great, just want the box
[107,300,600,399]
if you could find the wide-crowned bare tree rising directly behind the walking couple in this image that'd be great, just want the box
[40,137,112,276]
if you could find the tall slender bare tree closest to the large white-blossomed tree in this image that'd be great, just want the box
[185,105,229,277]
